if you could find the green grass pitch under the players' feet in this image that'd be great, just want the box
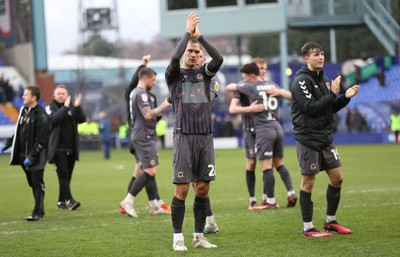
[0,145,400,257]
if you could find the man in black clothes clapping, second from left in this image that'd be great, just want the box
[46,85,86,211]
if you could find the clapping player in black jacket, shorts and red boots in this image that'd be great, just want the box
[291,42,360,237]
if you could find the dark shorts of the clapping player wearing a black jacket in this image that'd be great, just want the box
[296,141,342,175]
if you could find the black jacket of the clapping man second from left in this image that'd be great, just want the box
[46,100,86,163]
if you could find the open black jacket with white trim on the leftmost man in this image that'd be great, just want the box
[6,104,49,170]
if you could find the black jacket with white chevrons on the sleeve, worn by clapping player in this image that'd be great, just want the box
[290,66,350,151]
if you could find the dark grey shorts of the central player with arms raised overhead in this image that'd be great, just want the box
[173,134,215,184]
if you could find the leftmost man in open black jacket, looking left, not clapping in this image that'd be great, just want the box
[0,86,49,221]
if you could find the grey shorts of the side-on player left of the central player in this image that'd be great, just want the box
[132,137,158,169]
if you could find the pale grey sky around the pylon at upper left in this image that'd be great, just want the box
[44,0,160,56]
